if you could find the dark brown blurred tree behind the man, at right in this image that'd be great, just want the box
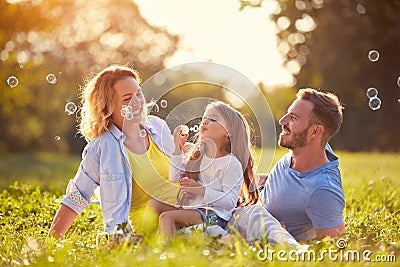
[271,0,400,151]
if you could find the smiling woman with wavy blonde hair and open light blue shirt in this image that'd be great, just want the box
[49,66,174,239]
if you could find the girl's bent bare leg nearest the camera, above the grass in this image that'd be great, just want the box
[158,209,203,240]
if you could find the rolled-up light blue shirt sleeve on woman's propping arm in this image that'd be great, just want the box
[61,143,100,214]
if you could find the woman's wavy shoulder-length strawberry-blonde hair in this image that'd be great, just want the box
[79,65,140,141]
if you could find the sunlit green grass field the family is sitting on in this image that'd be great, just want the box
[0,150,400,266]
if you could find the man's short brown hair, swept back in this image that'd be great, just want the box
[296,88,343,141]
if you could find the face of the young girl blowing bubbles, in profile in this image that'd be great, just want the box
[199,108,228,144]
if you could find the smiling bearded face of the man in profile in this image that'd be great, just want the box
[278,99,313,150]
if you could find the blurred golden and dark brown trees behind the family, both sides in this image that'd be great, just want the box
[0,0,400,152]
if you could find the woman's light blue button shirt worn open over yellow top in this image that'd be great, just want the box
[61,116,175,233]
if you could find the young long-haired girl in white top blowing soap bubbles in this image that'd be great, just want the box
[147,101,258,239]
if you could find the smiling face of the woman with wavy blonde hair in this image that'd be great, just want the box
[111,76,145,130]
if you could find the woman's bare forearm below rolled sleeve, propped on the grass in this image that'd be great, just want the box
[48,204,78,239]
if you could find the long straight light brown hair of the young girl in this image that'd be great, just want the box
[182,101,259,206]
